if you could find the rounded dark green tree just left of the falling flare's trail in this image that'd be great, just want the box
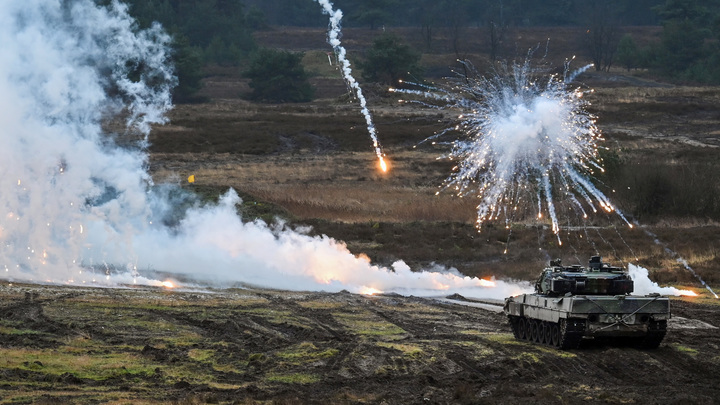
[243,48,315,103]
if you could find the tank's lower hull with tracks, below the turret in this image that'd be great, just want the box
[504,294,670,349]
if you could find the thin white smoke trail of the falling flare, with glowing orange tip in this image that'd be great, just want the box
[313,0,387,171]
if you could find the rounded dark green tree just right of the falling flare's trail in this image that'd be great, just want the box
[358,33,422,84]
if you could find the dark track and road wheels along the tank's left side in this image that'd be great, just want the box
[508,315,584,350]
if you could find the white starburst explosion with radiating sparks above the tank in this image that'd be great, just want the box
[391,60,632,243]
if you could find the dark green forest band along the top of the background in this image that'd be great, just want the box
[118,0,720,102]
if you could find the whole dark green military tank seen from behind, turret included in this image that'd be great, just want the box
[503,256,670,349]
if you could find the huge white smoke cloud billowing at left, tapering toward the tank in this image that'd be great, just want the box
[0,0,528,298]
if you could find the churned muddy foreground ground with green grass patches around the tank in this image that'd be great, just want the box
[0,283,720,404]
